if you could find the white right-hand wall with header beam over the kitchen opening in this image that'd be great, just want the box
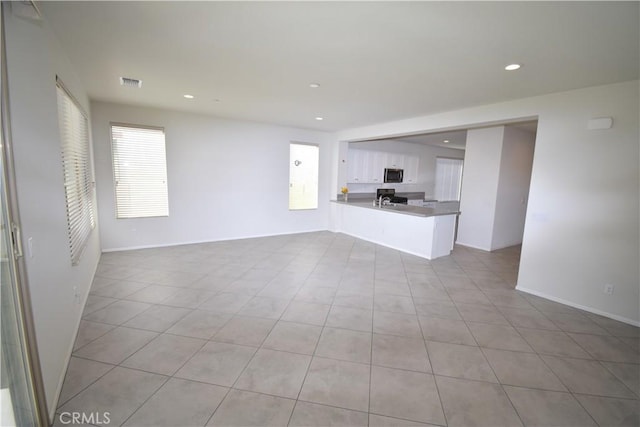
[338,80,640,324]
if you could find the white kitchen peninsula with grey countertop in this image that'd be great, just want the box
[331,198,460,260]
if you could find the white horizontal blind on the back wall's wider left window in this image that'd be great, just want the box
[111,124,169,218]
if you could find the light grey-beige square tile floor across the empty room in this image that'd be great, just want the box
[56,232,640,426]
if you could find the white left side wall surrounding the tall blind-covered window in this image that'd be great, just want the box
[5,5,100,416]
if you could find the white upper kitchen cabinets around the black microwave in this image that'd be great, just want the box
[347,150,418,184]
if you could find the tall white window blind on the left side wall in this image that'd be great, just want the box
[57,82,95,265]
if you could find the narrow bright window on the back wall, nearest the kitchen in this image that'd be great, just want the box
[289,143,320,210]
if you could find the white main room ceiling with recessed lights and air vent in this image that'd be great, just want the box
[40,1,640,131]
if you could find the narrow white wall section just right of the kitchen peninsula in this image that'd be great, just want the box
[456,126,504,251]
